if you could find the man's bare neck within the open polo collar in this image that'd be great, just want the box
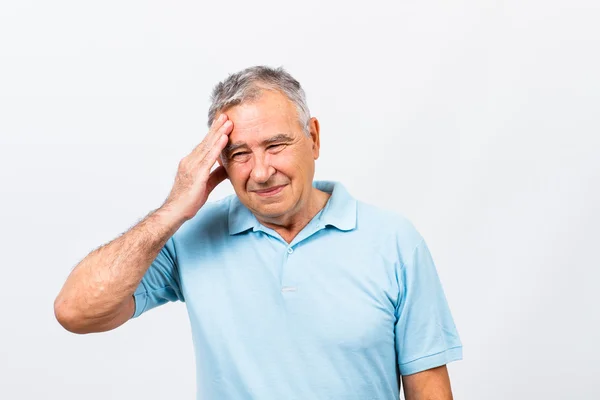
[259,188,331,243]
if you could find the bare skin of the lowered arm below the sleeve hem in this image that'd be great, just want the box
[402,365,453,400]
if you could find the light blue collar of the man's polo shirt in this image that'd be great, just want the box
[229,181,356,235]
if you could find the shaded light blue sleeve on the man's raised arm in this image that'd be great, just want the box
[131,237,185,318]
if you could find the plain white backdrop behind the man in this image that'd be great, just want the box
[0,0,600,400]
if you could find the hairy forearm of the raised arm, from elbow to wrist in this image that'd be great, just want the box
[54,208,185,331]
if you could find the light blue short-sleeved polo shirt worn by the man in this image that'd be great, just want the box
[134,181,462,400]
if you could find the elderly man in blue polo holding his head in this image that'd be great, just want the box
[55,67,462,400]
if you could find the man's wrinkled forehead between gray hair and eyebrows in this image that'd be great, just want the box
[225,90,301,144]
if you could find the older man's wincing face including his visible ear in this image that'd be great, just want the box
[222,90,319,222]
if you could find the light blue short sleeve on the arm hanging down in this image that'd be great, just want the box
[395,240,462,375]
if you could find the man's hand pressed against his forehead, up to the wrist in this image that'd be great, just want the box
[161,114,233,219]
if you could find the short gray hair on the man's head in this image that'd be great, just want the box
[208,65,310,136]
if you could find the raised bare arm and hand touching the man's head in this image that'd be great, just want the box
[54,114,233,333]
